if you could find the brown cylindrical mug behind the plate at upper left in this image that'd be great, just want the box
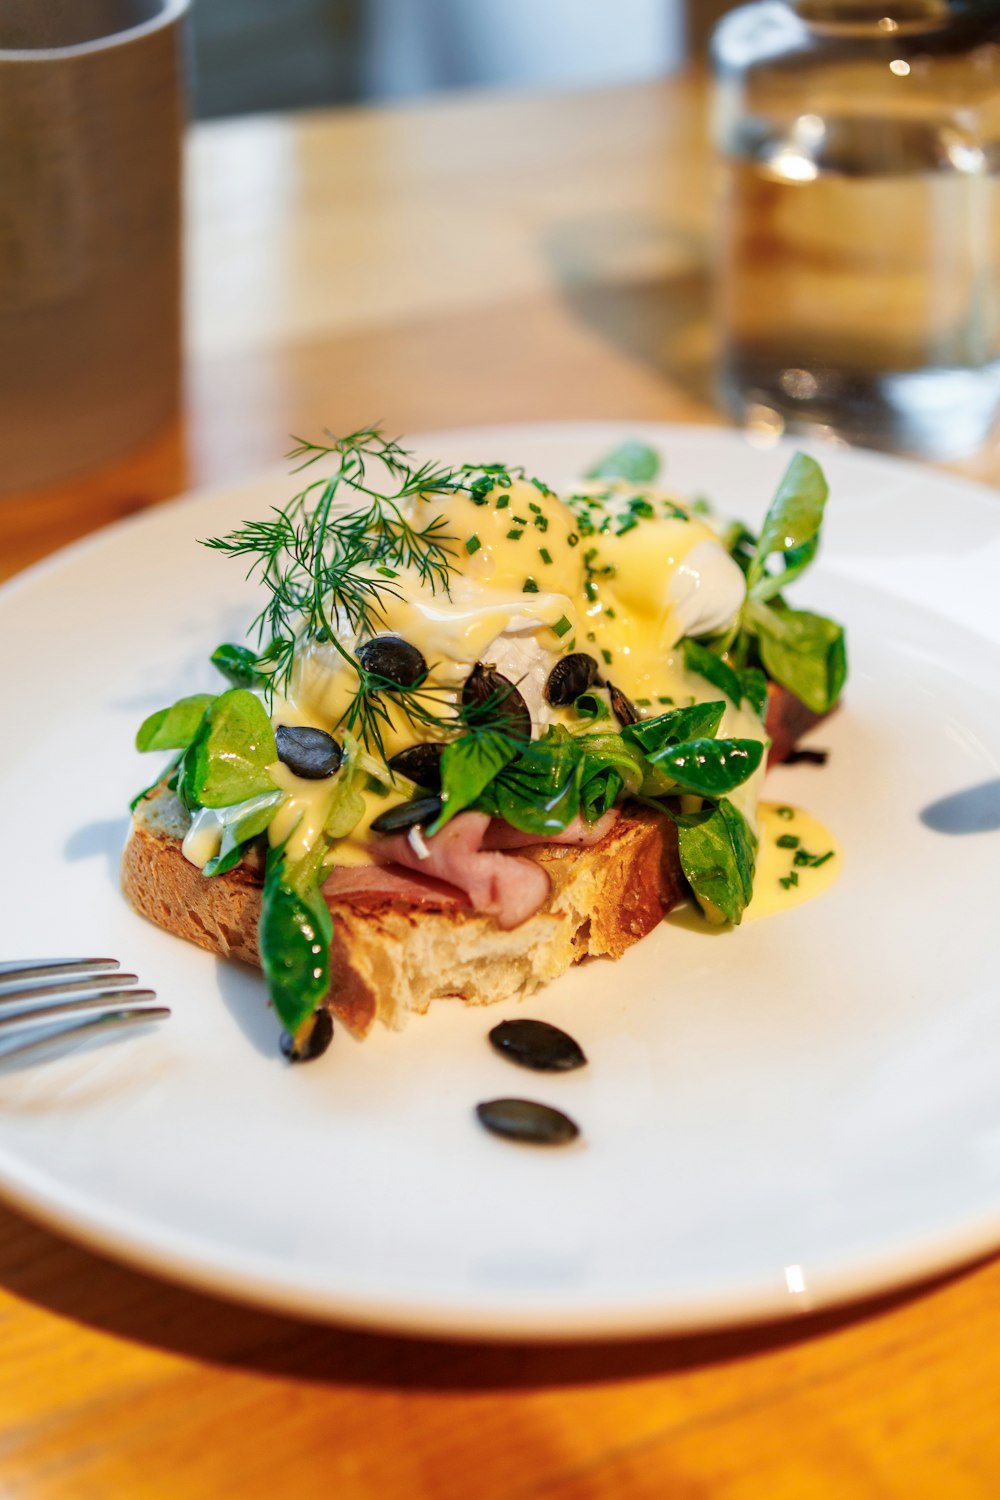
[0,0,189,492]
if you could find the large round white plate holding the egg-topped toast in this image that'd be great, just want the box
[0,425,1000,1338]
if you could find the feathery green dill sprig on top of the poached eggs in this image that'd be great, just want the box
[204,428,465,699]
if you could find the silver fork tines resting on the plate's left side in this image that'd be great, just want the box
[0,959,169,1064]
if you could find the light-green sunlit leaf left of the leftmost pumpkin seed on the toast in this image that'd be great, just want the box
[177,687,277,809]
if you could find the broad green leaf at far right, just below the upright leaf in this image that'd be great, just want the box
[747,599,847,714]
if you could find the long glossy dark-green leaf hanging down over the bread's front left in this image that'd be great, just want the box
[258,840,333,1034]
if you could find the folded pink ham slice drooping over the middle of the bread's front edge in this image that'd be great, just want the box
[372,813,550,930]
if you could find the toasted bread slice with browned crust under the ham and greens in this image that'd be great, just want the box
[121,788,685,1035]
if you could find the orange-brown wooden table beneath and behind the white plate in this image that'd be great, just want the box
[0,70,1000,1500]
